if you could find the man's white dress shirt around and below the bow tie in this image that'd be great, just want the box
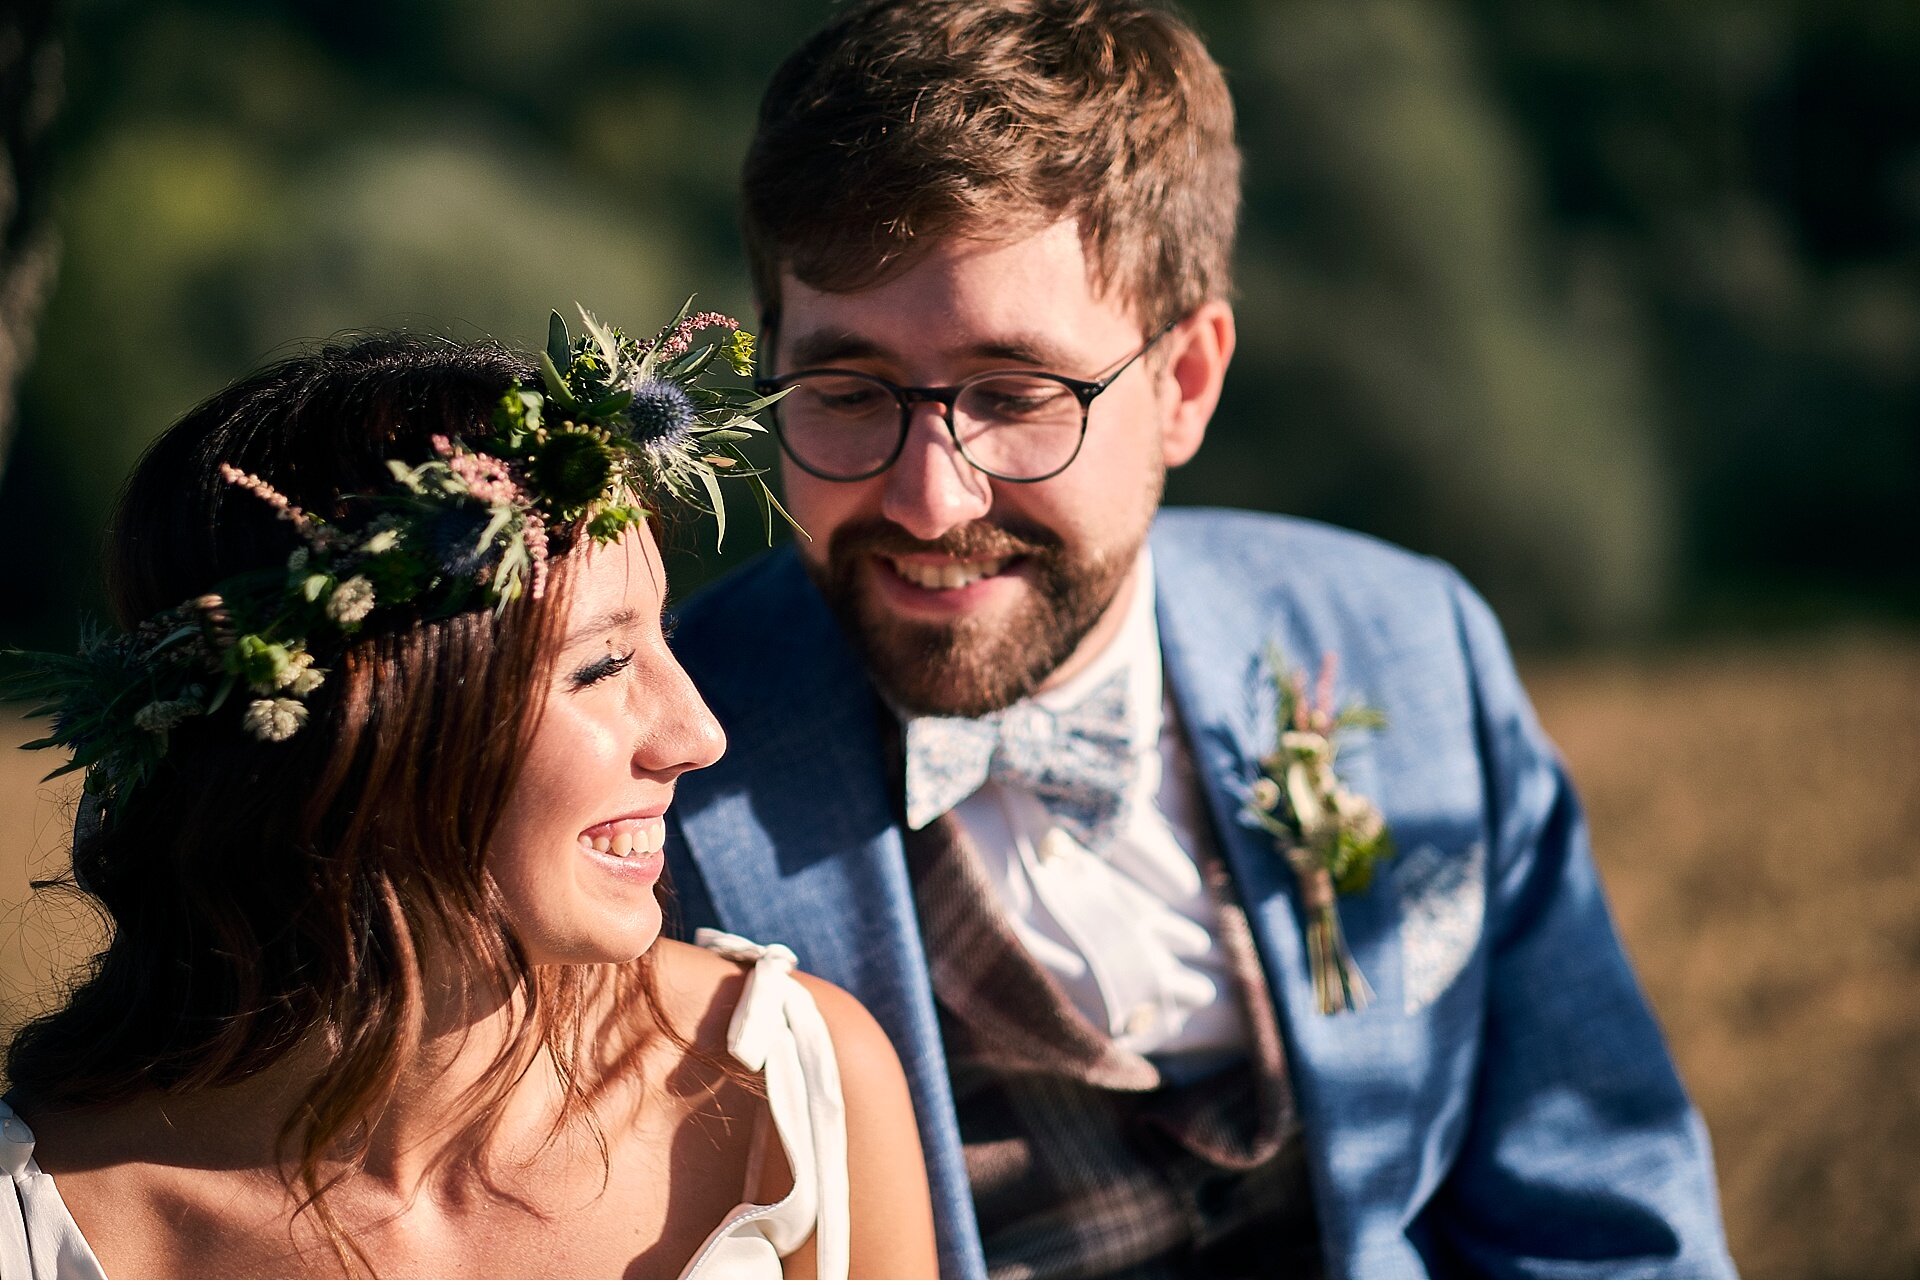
[952,547,1248,1062]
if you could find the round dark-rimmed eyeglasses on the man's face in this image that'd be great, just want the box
[755,317,1179,482]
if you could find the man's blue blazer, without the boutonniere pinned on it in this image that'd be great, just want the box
[668,511,1732,1277]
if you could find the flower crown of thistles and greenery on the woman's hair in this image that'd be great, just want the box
[0,300,791,807]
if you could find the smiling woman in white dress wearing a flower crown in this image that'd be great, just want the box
[0,315,937,1277]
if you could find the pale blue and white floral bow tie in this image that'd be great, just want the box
[906,672,1139,853]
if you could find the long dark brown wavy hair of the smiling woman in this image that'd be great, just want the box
[6,336,685,1268]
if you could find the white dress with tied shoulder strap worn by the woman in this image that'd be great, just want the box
[0,928,849,1281]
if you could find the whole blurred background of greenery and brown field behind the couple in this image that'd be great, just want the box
[0,0,1920,1275]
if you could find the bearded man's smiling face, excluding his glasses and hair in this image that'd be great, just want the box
[770,223,1198,713]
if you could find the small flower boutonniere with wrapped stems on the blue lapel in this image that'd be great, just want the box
[1242,645,1394,1014]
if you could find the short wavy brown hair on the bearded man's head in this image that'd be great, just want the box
[741,0,1240,325]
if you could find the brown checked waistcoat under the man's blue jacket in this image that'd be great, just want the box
[906,816,1321,1279]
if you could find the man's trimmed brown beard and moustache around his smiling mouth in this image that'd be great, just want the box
[808,519,1144,716]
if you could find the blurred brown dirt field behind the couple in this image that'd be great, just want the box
[0,638,1920,1277]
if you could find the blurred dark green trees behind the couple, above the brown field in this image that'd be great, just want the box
[0,0,1920,642]
